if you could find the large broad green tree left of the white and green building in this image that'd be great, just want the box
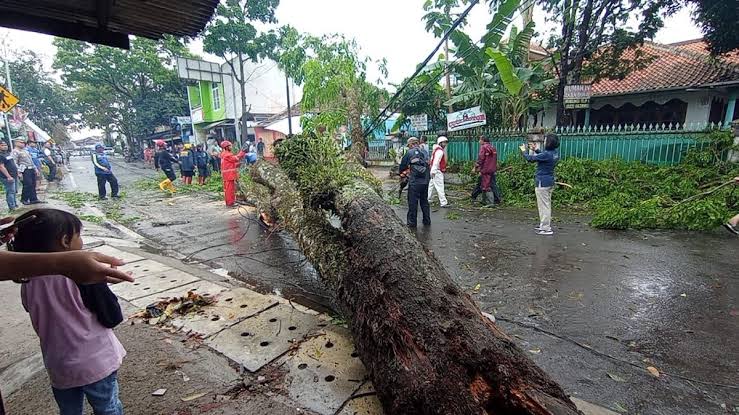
[54,38,189,147]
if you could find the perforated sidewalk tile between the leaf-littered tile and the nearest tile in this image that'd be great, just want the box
[206,304,319,372]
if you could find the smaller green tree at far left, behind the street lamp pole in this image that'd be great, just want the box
[0,50,74,134]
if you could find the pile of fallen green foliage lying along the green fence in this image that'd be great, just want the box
[498,132,739,230]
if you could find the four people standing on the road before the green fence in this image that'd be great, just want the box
[398,134,559,235]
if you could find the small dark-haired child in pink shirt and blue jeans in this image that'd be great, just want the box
[8,209,126,415]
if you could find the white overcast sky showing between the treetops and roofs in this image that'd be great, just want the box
[0,0,701,138]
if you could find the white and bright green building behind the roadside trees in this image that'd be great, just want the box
[177,58,302,142]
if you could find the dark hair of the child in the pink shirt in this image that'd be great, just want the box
[8,209,82,252]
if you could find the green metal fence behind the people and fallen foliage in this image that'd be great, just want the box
[420,125,724,165]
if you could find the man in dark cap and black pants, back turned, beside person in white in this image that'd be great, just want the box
[399,137,431,228]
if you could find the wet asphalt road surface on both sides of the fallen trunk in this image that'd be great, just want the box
[63,158,739,415]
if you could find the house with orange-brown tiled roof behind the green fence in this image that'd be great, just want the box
[536,39,739,128]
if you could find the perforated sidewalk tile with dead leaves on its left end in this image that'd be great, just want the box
[170,288,277,337]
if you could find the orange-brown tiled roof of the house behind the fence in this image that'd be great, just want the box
[593,40,739,96]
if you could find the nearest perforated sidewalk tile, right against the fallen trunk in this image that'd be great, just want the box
[285,326,367,414]
